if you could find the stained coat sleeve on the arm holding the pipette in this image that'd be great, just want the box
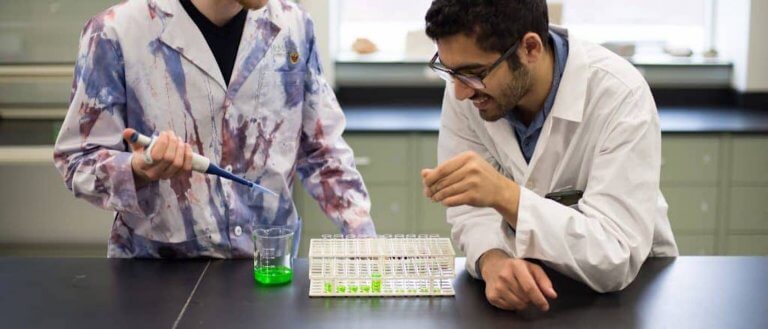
[54,15,158,217]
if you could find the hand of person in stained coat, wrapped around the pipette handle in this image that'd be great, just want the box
[123,128,192,187]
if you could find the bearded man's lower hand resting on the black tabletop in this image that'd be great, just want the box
[478,249,557,311]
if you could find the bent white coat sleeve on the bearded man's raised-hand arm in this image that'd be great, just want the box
[502,90,661,292]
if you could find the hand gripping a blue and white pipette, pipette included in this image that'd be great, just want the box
[123,128,277,196]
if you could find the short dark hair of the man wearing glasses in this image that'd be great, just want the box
[425,0,549,67]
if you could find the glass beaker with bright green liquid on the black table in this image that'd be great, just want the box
[253,225,295,285]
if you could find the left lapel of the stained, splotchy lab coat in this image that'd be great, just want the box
[158,1,227,90]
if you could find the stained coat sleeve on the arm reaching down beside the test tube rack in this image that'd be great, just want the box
[296,16,376,236]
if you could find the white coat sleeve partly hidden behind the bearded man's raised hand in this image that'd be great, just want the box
[437,83,508,278]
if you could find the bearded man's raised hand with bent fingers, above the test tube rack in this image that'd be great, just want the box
[421,151,520,226]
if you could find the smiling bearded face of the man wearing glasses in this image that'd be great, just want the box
[437,33,533,121]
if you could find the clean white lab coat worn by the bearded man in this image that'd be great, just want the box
[438,27,678,292]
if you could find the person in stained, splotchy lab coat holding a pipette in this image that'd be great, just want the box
[54,0,375,258]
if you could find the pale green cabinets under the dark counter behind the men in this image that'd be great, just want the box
[295,132,768,255]
